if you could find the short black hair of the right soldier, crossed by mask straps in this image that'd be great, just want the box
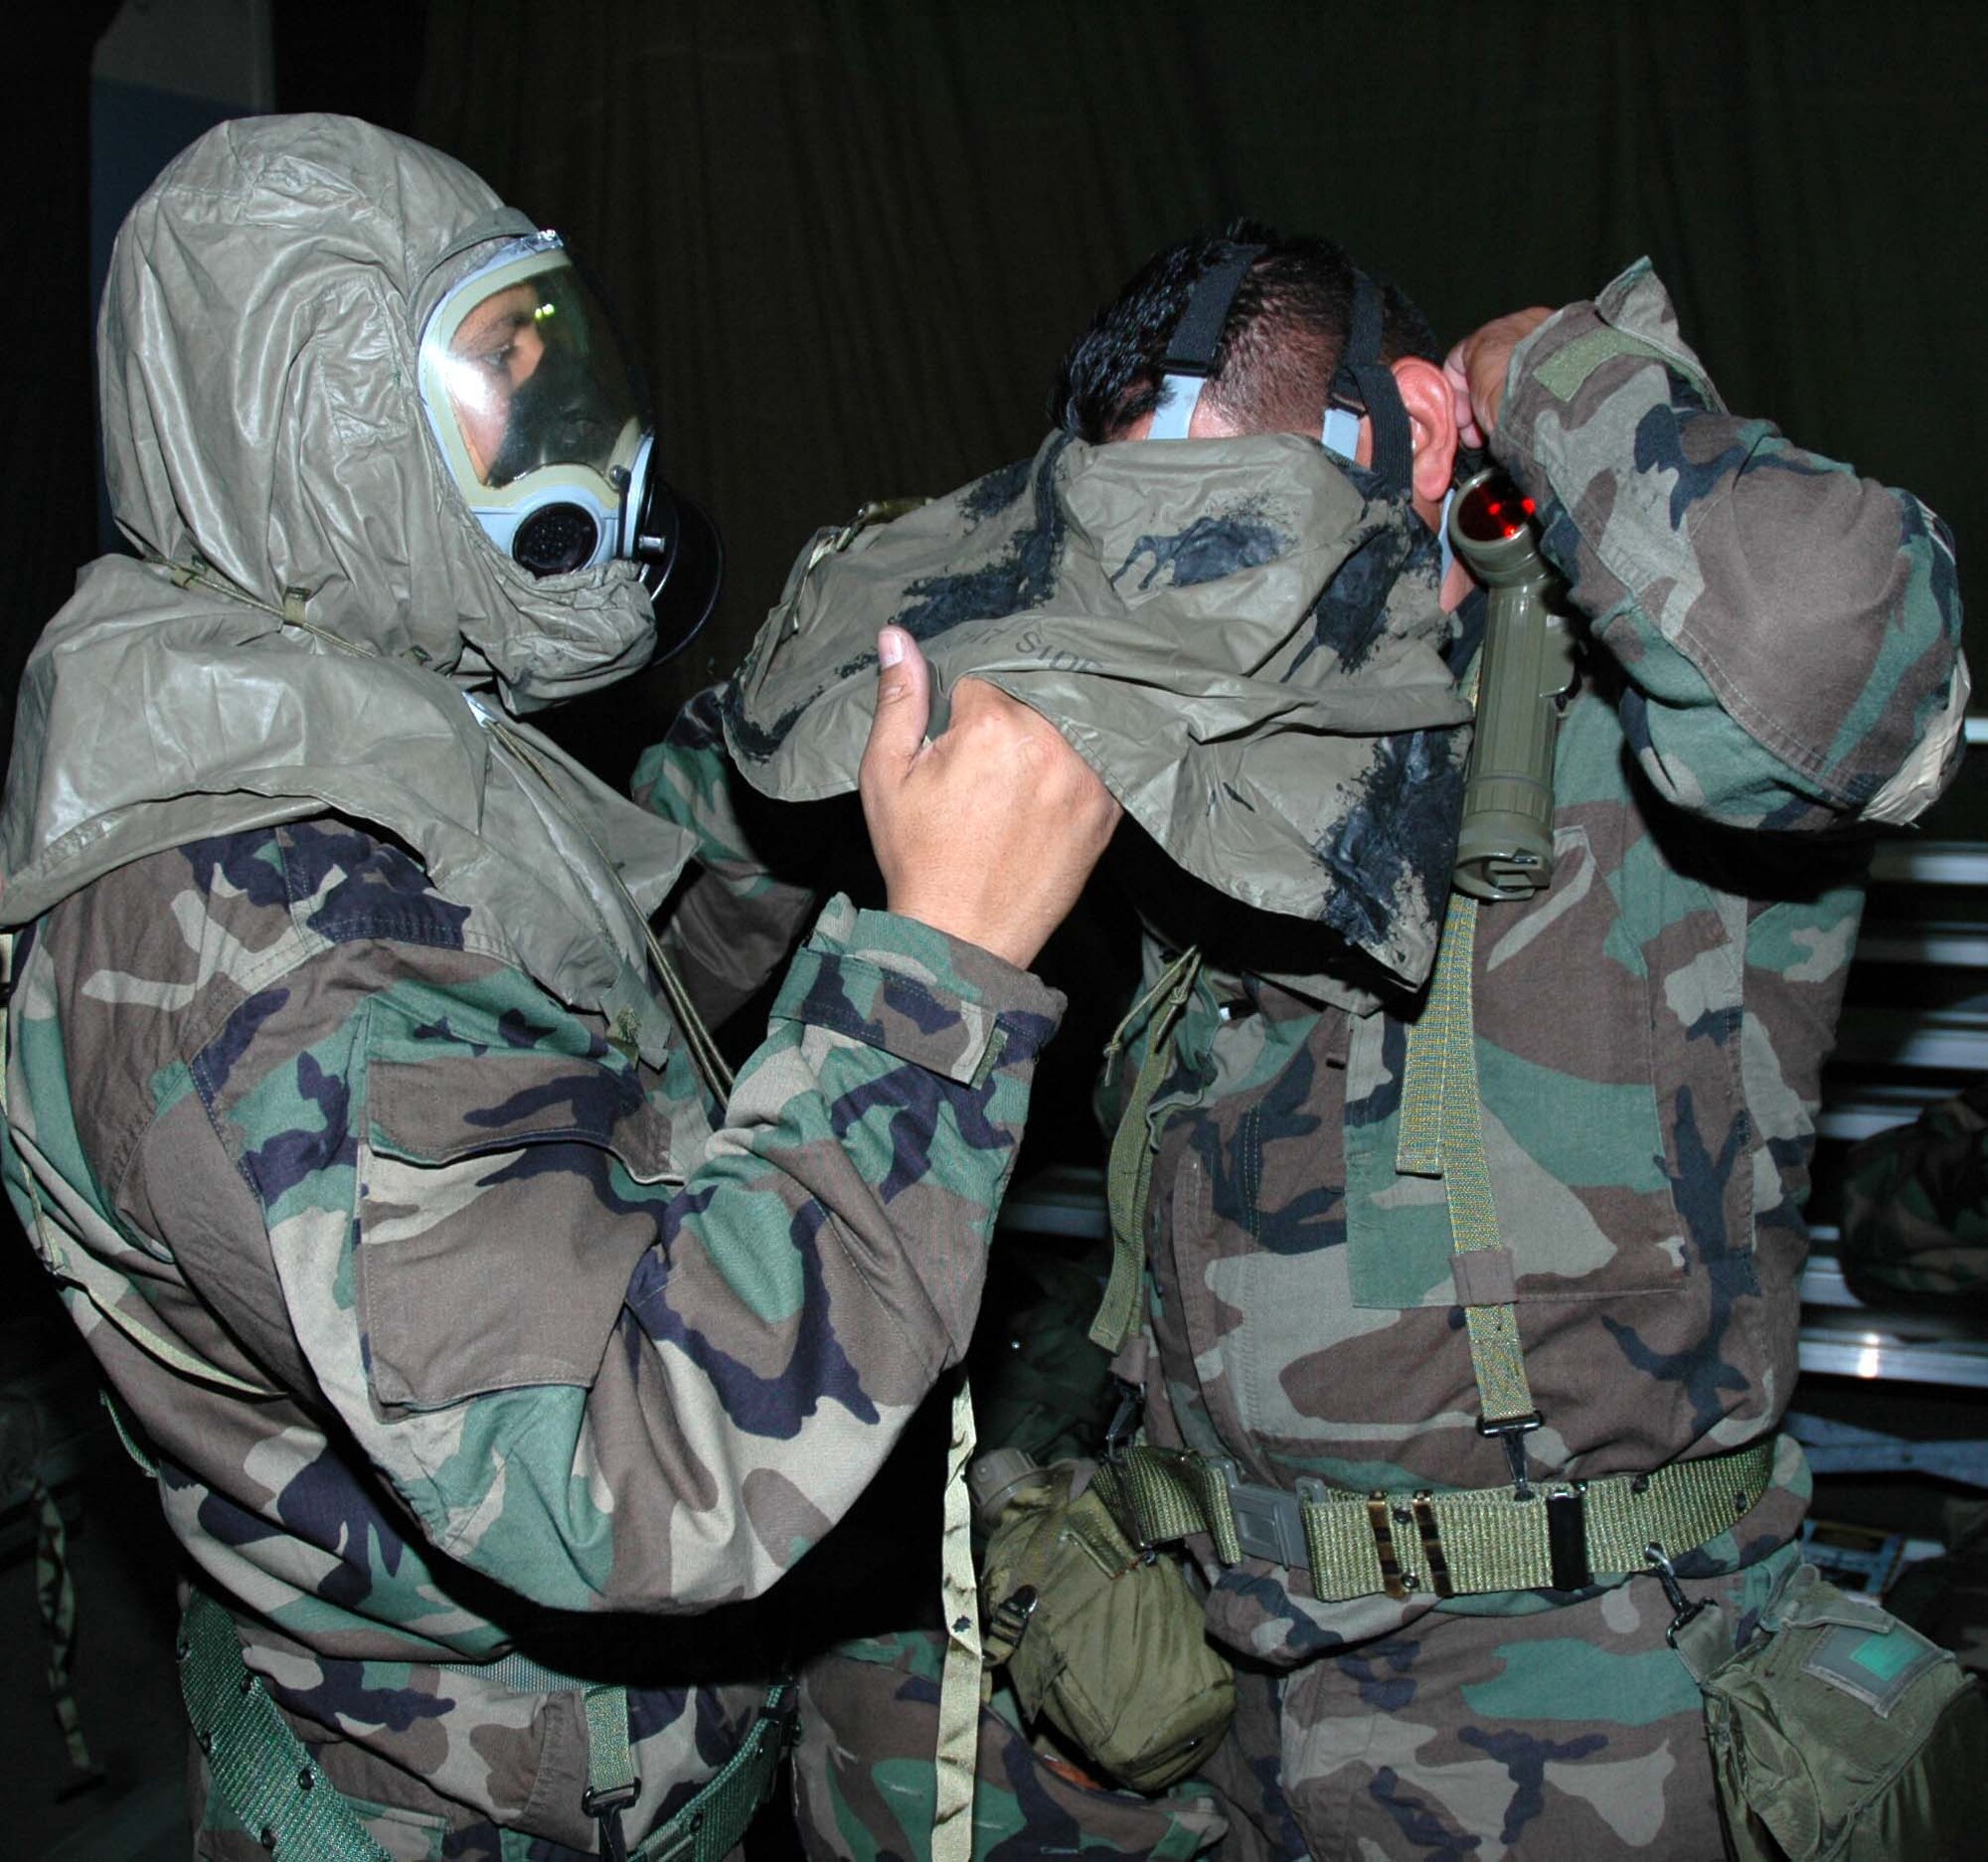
[1050,219,1441,445]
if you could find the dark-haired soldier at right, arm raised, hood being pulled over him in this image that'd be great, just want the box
[700,225,1968,1858]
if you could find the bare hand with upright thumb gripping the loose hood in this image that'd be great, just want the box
[857,626,1119,969]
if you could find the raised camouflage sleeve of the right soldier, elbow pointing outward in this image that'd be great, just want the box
[1493,260,1968,827]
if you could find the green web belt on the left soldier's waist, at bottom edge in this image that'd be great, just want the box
[175,1592,793,1862]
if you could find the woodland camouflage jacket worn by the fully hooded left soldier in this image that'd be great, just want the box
[8,817,1058,1854]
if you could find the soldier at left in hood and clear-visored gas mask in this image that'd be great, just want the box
[0,117,1117,1858]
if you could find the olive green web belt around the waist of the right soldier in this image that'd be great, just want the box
[1097,1437,1775,1604]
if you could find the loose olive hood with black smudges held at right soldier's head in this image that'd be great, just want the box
[726,433,1471,985]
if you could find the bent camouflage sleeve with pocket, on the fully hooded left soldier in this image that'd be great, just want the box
[145,899,1062,1611]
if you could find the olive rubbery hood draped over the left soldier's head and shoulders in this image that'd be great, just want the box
[0,115,688,1049]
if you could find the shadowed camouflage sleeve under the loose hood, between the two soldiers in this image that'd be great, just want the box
[634,686,819,1027]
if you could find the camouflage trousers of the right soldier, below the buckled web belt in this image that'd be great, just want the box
[795,1546,1797,1862]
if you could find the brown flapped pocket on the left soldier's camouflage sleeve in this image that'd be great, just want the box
[358,1015,672,1411]
